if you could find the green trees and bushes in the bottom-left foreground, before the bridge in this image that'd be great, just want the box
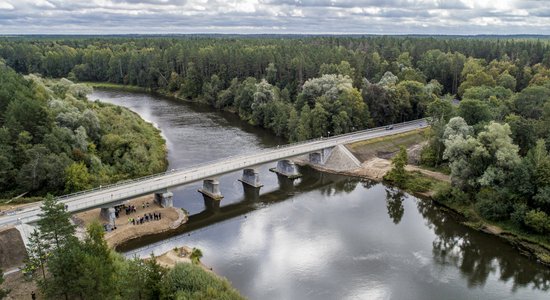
[23,196,243,300]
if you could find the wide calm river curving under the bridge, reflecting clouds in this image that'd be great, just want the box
[89,90,550,299]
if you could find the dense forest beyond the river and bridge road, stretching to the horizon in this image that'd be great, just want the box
[4,37,550,141]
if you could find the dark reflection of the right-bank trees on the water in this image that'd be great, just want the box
[418,201,550,291]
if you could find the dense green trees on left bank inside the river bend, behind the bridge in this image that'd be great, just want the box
[0,62,166,198]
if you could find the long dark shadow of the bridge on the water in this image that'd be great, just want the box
[116,167,361,252]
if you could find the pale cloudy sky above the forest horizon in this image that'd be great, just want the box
[0,0,550,35]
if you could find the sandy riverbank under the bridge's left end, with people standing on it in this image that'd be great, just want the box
[73,195,188,248]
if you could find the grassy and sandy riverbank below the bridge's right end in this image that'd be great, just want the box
[302,132,550,266]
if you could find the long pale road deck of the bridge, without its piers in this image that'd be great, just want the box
[0,119,428,226]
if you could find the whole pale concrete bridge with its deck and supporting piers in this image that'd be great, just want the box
[0,119,428,235]
